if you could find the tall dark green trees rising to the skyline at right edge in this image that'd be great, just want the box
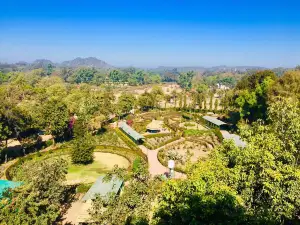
[224,67,300,123]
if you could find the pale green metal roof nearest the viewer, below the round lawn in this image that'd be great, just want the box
[81,175,123,201]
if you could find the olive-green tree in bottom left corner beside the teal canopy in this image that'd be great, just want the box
[0,158,67,225]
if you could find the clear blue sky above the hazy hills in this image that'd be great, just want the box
[0,0,300,67]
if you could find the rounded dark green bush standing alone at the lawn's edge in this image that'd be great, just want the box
[71,136,94,164]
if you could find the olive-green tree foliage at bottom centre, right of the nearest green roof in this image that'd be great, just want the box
[90,160,160,224]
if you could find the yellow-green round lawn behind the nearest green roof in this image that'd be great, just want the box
[67,152,129,184]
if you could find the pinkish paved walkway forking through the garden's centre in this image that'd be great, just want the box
[139,138,186,179]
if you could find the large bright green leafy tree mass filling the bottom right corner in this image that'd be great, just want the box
[154,101,300,224]
